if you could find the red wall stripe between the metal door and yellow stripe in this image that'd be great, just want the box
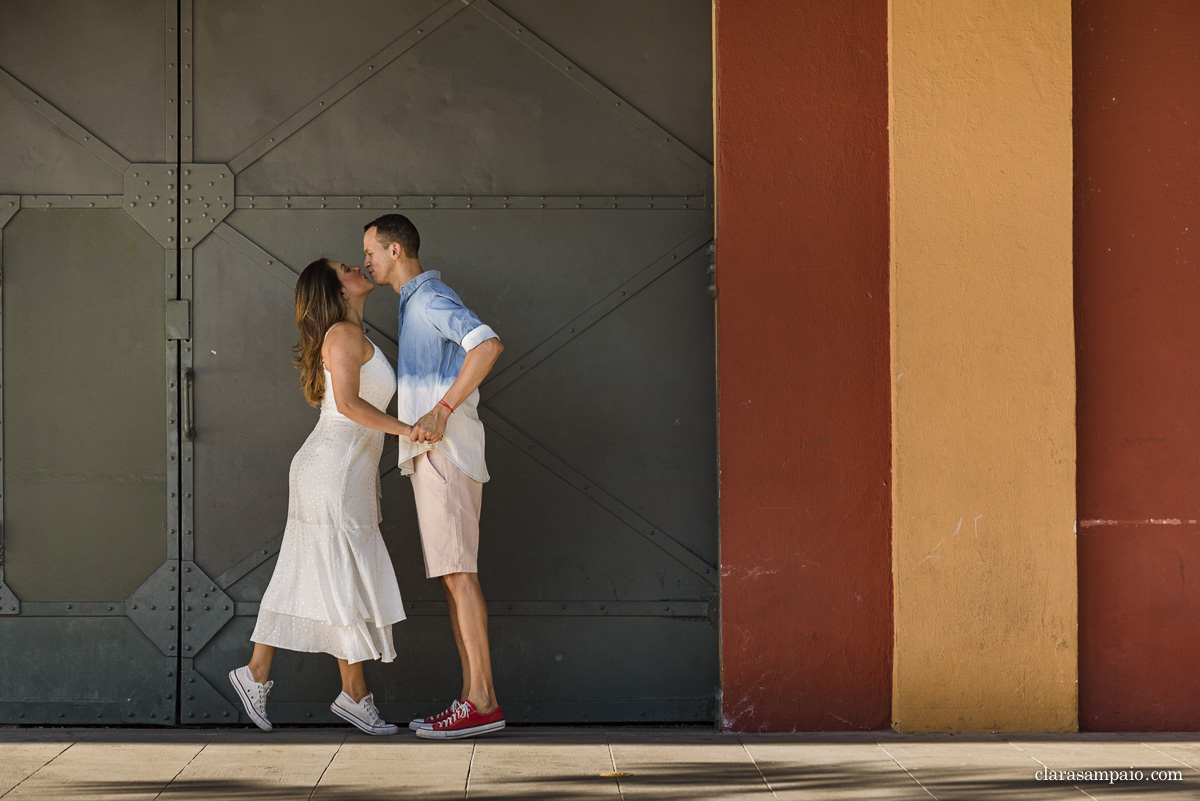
[716,0,892,731]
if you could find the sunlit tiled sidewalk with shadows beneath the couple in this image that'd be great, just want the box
[0,727,1200,801]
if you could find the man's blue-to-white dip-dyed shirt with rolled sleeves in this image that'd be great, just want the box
[396,270,498,481]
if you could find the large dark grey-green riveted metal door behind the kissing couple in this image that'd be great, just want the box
[0,0,719,723]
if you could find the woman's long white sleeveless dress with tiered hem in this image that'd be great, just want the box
[251,343,404,662]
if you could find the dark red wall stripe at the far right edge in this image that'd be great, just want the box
[1073,0,1200,731]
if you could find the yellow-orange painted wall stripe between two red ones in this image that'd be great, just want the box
[892,0,1078,731]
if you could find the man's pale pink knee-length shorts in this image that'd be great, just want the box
[409,451,484,578]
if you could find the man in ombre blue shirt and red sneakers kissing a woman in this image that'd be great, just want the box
[362,215,504,740]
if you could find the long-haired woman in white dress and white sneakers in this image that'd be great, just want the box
[229,259,409,734]
